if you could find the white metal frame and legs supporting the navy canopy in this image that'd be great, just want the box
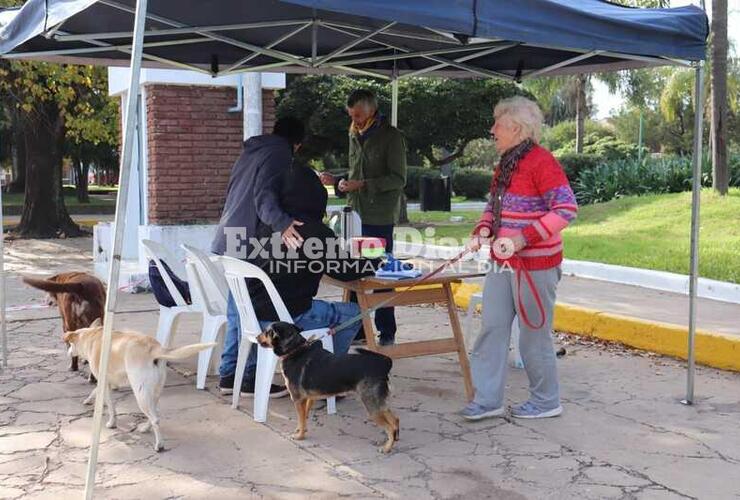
[0,0,704,499]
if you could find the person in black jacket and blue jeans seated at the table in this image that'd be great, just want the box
[220,153,380,397]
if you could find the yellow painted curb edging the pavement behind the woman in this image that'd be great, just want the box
[454,284,740,371]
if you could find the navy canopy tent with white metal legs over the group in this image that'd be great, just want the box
[0,0,708,498]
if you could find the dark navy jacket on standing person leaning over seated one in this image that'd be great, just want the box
[211,134,293,255]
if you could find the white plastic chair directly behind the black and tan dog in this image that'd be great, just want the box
[219,257,337,422]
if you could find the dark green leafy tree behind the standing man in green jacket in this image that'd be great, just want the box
[277,75,529,167]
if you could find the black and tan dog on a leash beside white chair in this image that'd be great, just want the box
[257,321,398,453]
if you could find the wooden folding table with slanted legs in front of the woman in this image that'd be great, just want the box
[324,273,484,399]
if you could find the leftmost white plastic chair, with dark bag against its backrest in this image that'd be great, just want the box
[141,240,201,347]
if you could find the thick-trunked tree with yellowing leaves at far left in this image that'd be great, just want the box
[0,60,105,238]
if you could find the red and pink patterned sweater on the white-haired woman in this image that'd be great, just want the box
[473,145,578,271]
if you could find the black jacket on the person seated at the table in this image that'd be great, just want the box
[248,165,380,321]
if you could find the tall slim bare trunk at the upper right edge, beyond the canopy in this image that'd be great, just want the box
[711,0,730,196]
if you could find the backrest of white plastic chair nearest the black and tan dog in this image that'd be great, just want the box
[218,256,293,337]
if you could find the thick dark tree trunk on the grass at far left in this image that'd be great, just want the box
[16,102,84,238]
